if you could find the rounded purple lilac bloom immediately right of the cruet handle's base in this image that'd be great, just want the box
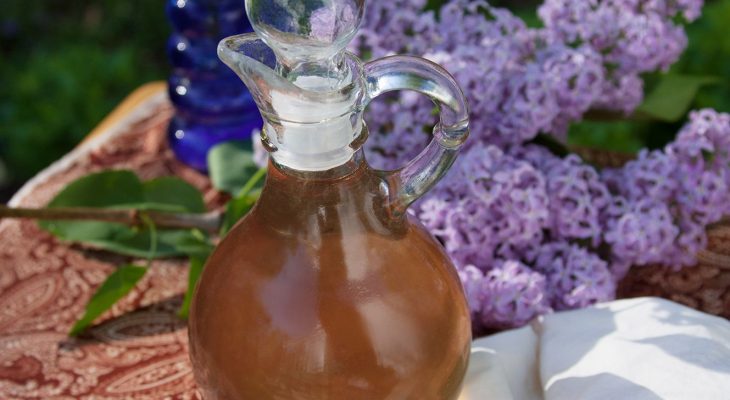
[416,144,549,271]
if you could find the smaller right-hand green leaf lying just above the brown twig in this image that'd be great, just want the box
[143,177,205,213]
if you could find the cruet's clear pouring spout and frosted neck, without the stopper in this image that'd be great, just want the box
[218,34,365,171]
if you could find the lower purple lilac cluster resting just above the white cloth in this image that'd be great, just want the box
[424,106,730,330]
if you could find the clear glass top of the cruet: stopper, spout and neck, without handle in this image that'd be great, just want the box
[218,0,365,171]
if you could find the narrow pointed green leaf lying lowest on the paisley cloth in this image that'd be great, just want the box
[69,265,147,336]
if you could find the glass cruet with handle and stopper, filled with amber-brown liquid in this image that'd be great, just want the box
[189,0,471,400]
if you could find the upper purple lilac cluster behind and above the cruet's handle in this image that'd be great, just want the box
[352,0,702,162]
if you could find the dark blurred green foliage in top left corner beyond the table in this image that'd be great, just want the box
[0,0,169,201]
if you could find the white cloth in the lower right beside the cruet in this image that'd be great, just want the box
[459,298,730,400]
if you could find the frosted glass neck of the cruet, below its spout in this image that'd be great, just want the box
[253,53,367,171]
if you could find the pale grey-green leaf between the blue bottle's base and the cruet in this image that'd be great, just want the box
[208,141,259,195]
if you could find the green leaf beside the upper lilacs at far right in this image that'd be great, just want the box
[637,74,719,122]
